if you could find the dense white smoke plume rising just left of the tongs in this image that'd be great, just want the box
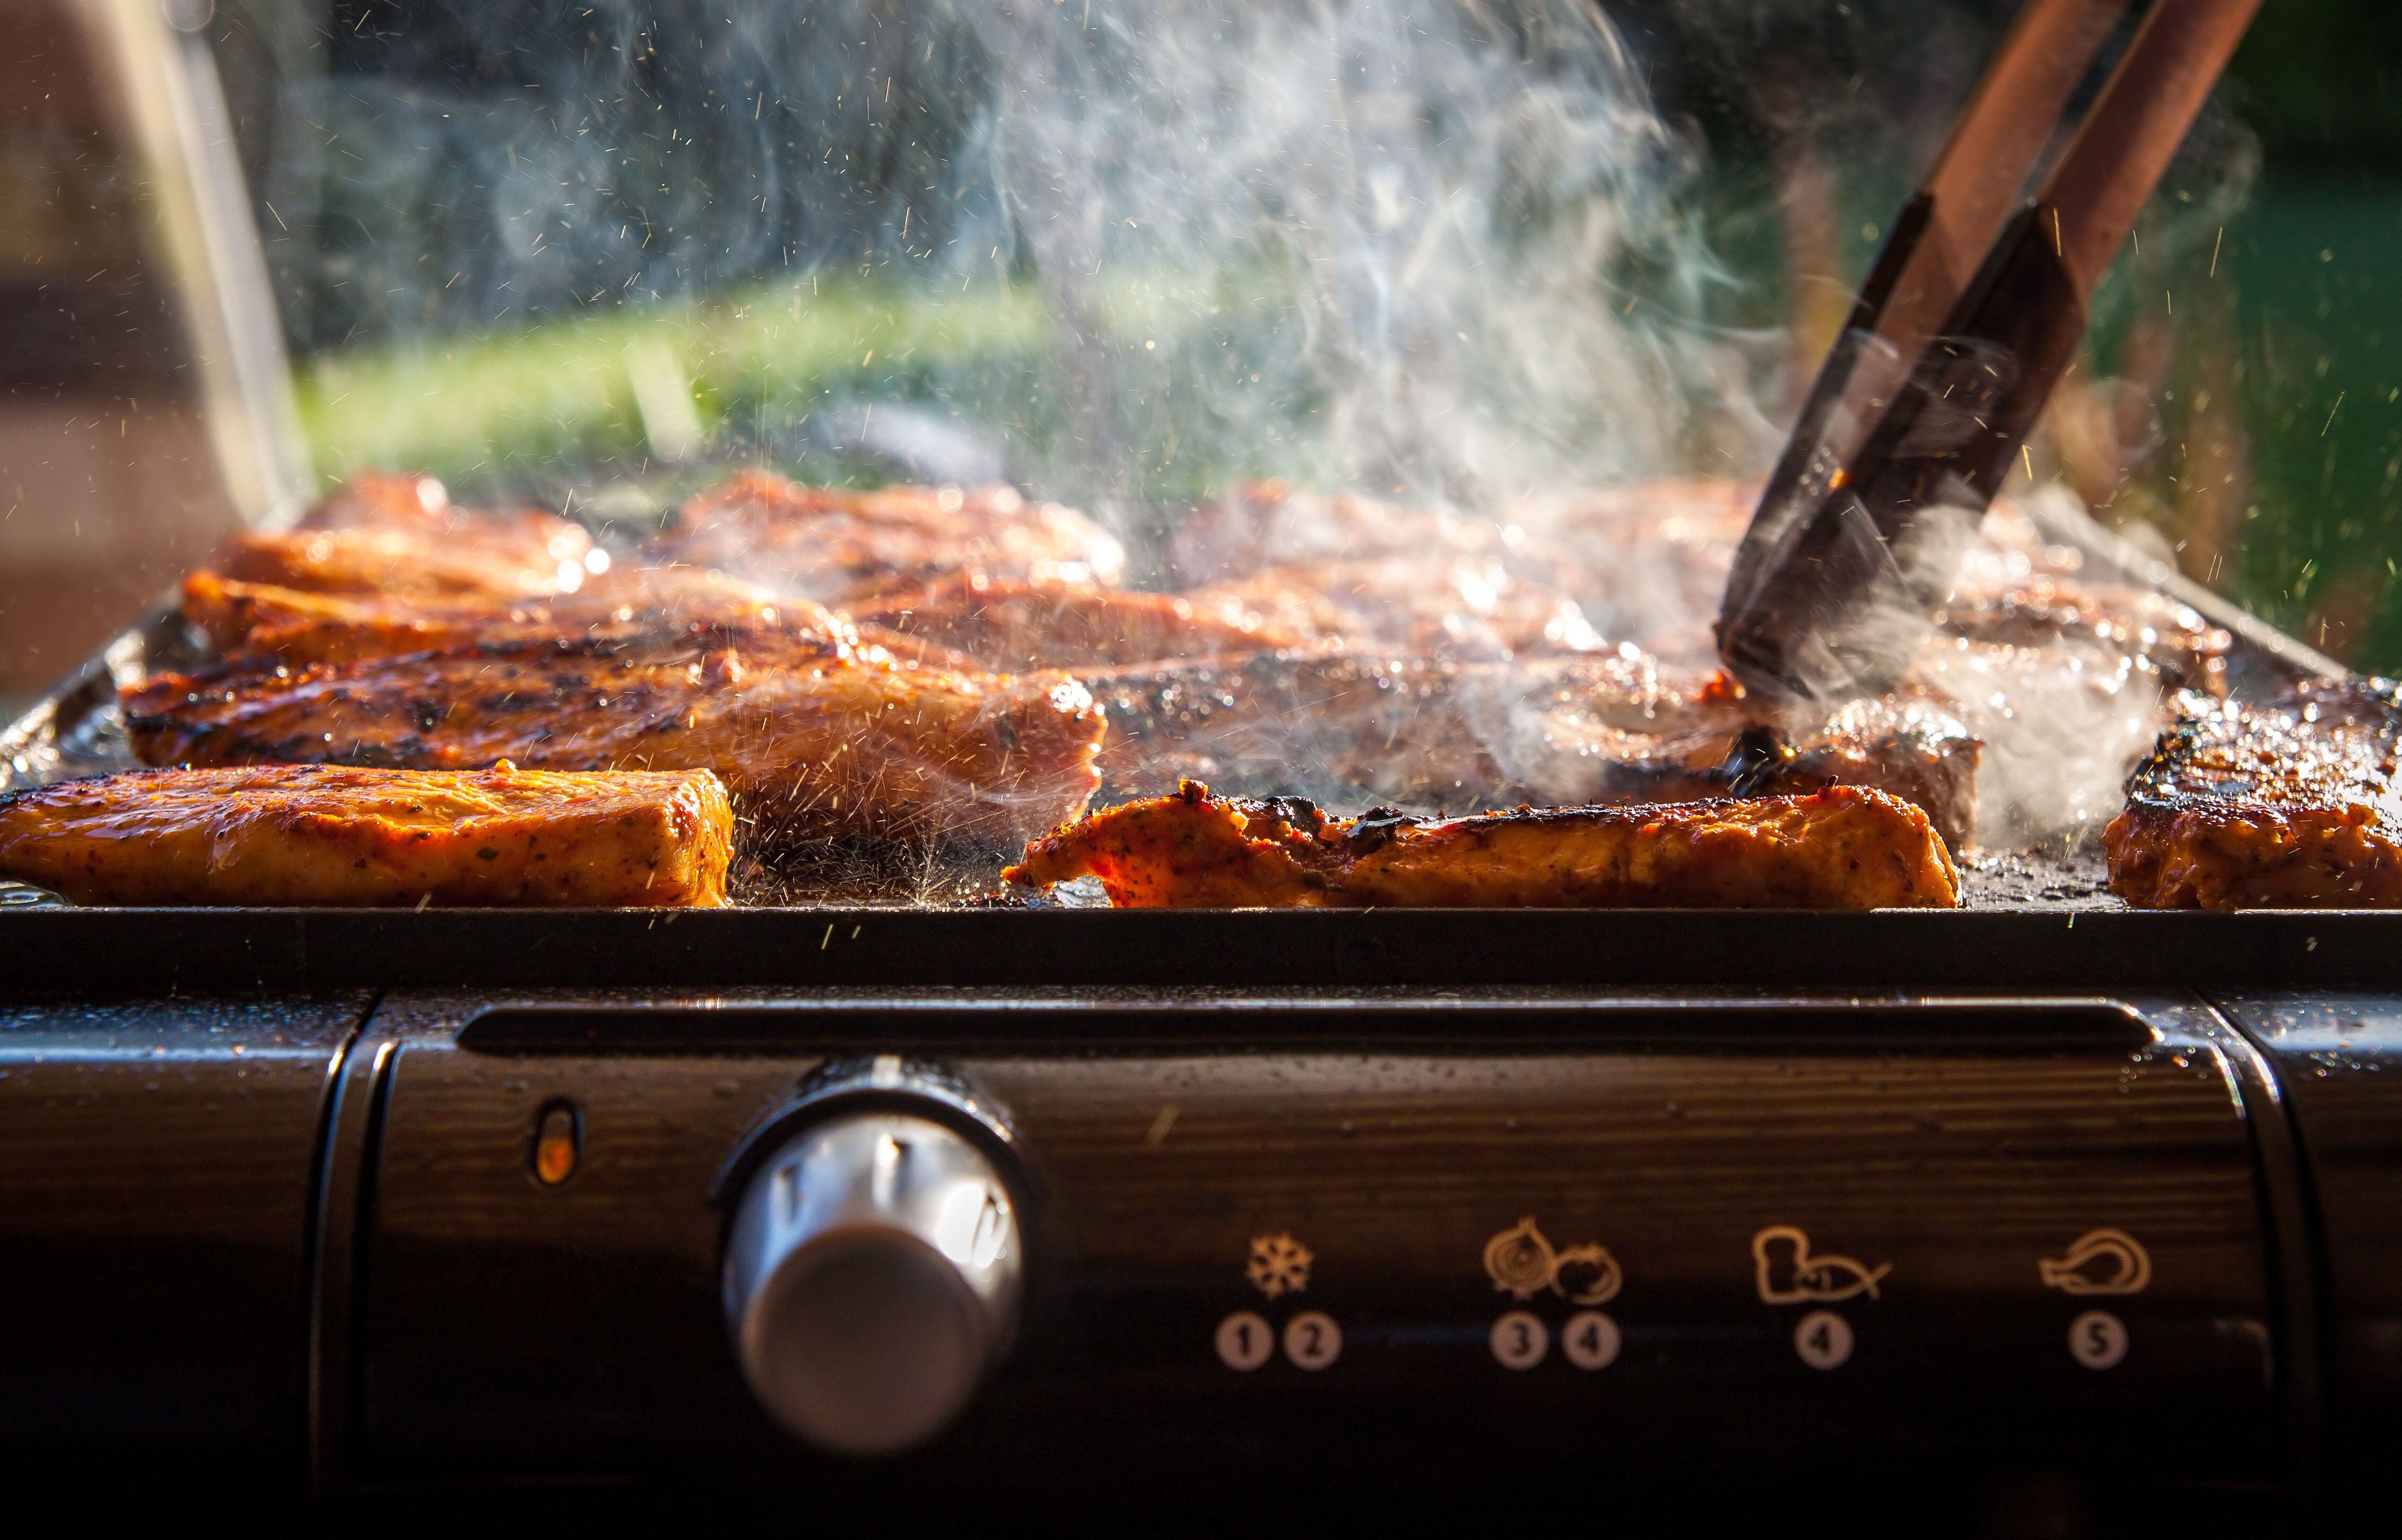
[951,0,1768,509]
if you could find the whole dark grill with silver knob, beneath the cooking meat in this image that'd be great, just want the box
[0,502,2402,1502]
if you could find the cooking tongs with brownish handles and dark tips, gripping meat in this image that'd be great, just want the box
[1718,0,2260,699]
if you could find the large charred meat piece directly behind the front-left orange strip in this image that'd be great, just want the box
[125,639,1102,848]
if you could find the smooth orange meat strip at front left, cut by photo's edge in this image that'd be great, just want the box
[0,764,733,908]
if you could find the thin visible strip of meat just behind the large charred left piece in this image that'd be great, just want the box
[182,567,980,673]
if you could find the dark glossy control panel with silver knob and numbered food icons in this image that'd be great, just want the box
[329,999,2284,1480]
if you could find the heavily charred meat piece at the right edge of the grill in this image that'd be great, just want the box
[2102,680,2402,908]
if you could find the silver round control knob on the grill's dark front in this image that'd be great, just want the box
[725,1112,1021,1454]
